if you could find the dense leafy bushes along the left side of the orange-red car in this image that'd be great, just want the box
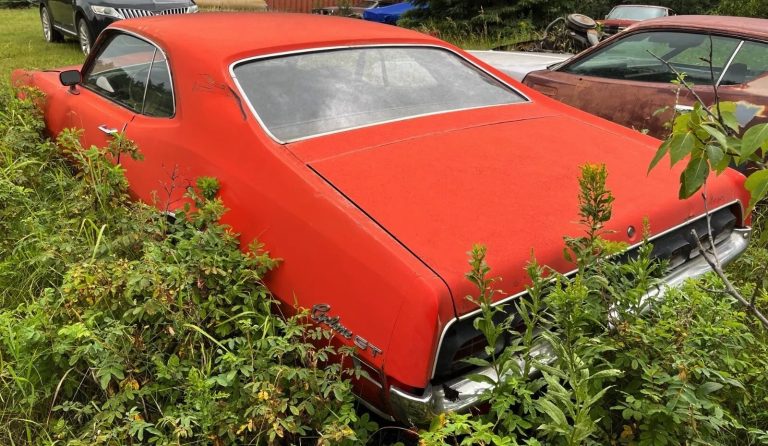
[0,91,374,445]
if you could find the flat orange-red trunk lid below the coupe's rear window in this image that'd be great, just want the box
[292,115,743,315]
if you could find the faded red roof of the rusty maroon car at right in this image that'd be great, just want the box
[632,15,768,40]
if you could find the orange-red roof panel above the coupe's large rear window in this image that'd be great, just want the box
[111,13,443,60]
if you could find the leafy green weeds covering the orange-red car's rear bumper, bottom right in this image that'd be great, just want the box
[422,166,768,445]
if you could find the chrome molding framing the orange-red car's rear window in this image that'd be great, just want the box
[229,43,532,145]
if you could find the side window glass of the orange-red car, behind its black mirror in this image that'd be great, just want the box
[83,34,174,117]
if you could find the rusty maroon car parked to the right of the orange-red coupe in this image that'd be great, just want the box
[524,16,768,137]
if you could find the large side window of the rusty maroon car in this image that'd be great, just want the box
[564,32,739,84]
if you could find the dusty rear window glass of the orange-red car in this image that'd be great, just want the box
[233,47,525,142]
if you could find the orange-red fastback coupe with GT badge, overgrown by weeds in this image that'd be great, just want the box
[15,14,749,423]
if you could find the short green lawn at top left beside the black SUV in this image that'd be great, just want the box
[0,8,84,88]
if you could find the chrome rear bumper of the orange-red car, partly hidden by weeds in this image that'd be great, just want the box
[389,228,752,425]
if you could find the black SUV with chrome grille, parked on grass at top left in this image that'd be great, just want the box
[40,0,197,54]
